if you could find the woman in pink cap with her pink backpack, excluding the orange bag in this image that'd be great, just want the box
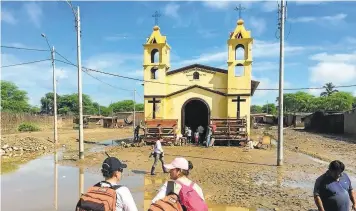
[152,157,207,211]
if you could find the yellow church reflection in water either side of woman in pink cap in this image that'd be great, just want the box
[144,175,267,211]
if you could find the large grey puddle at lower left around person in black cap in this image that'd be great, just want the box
[1,152,143,211]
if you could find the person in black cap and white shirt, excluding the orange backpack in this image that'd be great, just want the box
[100,157,137,211]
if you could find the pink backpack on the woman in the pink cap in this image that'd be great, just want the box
[176,181,208,211]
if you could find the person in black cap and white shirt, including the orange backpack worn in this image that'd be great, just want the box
[76,157,137,211]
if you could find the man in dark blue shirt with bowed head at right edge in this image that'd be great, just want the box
[314,160,356,211]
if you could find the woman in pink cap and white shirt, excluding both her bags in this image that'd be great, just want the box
[152,157,205,203]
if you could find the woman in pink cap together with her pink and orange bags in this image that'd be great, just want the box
[148,157,208,211]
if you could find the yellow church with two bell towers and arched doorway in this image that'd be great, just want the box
[143,16,259,134]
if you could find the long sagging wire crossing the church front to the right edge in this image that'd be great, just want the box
[57,57,356,91]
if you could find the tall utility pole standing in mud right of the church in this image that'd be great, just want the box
[277,0,285,166]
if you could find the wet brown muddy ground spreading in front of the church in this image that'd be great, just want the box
[1,129,356,210]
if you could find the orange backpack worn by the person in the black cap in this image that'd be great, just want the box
[75,181,122,211]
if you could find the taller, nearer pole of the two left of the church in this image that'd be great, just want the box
[76,7,84,159]
